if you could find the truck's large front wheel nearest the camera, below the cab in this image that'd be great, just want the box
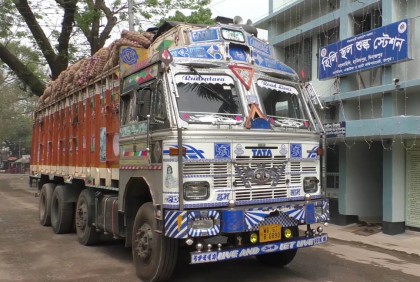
[132,203,178,281]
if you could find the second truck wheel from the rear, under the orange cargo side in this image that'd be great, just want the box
[51,185,74,234]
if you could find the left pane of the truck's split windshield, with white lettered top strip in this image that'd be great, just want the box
[175,74,243,124]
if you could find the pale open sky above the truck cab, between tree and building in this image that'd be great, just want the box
[210,0,268,23]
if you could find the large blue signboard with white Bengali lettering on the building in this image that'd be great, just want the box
[318,19,413,80]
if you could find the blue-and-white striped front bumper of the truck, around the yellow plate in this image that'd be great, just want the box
[164,199,329,239]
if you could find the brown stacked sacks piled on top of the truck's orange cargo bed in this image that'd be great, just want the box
[39,30,153,106]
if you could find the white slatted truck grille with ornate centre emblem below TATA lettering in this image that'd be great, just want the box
[184,156,316,201]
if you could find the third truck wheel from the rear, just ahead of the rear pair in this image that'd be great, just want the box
[76,189,101,246]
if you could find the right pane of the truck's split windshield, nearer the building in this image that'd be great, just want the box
[257,79,306,127]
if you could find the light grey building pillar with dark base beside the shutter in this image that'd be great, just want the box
[382,142,405,235]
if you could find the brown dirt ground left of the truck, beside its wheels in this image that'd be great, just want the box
[0,174,139,282]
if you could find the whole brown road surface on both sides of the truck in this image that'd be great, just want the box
[0,174,420,282]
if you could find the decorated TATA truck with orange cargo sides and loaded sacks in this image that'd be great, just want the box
[30,18,329,281]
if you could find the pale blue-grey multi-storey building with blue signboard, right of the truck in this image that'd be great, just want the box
[256,0,420,235]
